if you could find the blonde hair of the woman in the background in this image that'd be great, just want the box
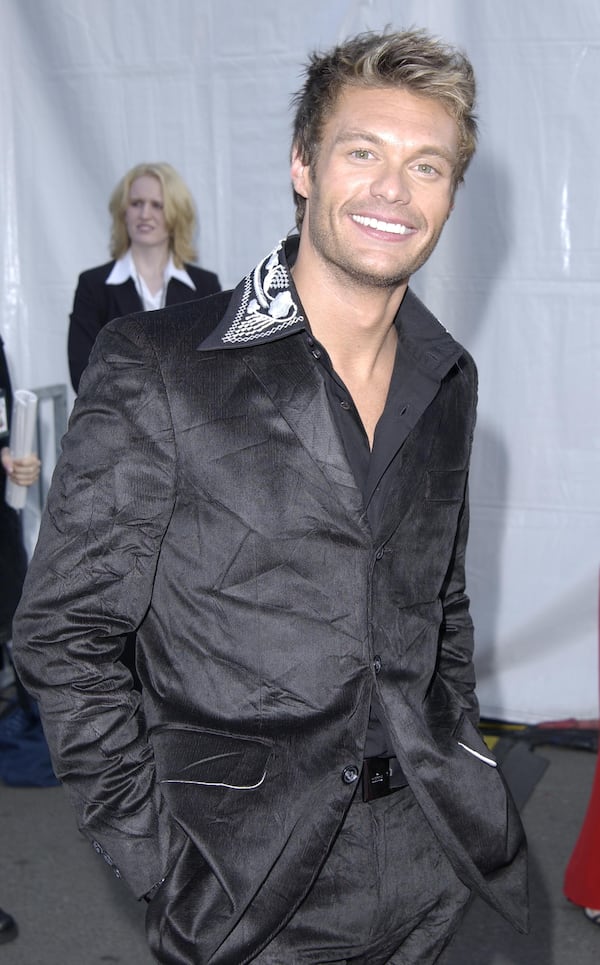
[108,161,198,268]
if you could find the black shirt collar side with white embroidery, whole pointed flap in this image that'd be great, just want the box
[200,236,306,349]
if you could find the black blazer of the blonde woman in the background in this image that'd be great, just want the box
[68,261,221,392]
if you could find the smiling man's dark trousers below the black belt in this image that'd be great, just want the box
[244,788,470,965]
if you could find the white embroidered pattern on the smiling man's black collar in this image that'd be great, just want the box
[221,241,304,345]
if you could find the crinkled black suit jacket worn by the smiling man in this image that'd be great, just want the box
[15,243,527,965]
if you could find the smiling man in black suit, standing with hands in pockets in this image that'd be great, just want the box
[15,31,527,965]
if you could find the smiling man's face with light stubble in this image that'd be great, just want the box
[292,87,458,288]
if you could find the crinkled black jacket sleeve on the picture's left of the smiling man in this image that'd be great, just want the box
[14,319,184,896]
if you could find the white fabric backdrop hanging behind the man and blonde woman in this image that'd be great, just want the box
[0,0,600,723]
